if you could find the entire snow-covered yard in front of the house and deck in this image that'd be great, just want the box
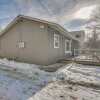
[0,59,100,100]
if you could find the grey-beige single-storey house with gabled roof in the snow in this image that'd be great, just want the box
[0,15,78,65]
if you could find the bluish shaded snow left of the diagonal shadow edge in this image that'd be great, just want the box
[0,59,55,100]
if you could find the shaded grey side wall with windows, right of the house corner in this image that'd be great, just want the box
[48,27,70,64]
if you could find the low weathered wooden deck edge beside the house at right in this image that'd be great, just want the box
[59,59,100,66]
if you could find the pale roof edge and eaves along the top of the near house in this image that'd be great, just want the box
[0,15,77,40]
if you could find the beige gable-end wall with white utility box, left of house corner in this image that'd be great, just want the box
[0,19,48,65]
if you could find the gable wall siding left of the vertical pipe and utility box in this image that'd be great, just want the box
[0,23,19,59]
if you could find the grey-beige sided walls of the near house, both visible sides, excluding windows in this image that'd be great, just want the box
[0,18,77,65]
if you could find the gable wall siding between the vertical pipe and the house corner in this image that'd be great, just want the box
[19,19,47,64]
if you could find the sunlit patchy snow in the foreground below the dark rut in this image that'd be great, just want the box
[28,83,100,100]
